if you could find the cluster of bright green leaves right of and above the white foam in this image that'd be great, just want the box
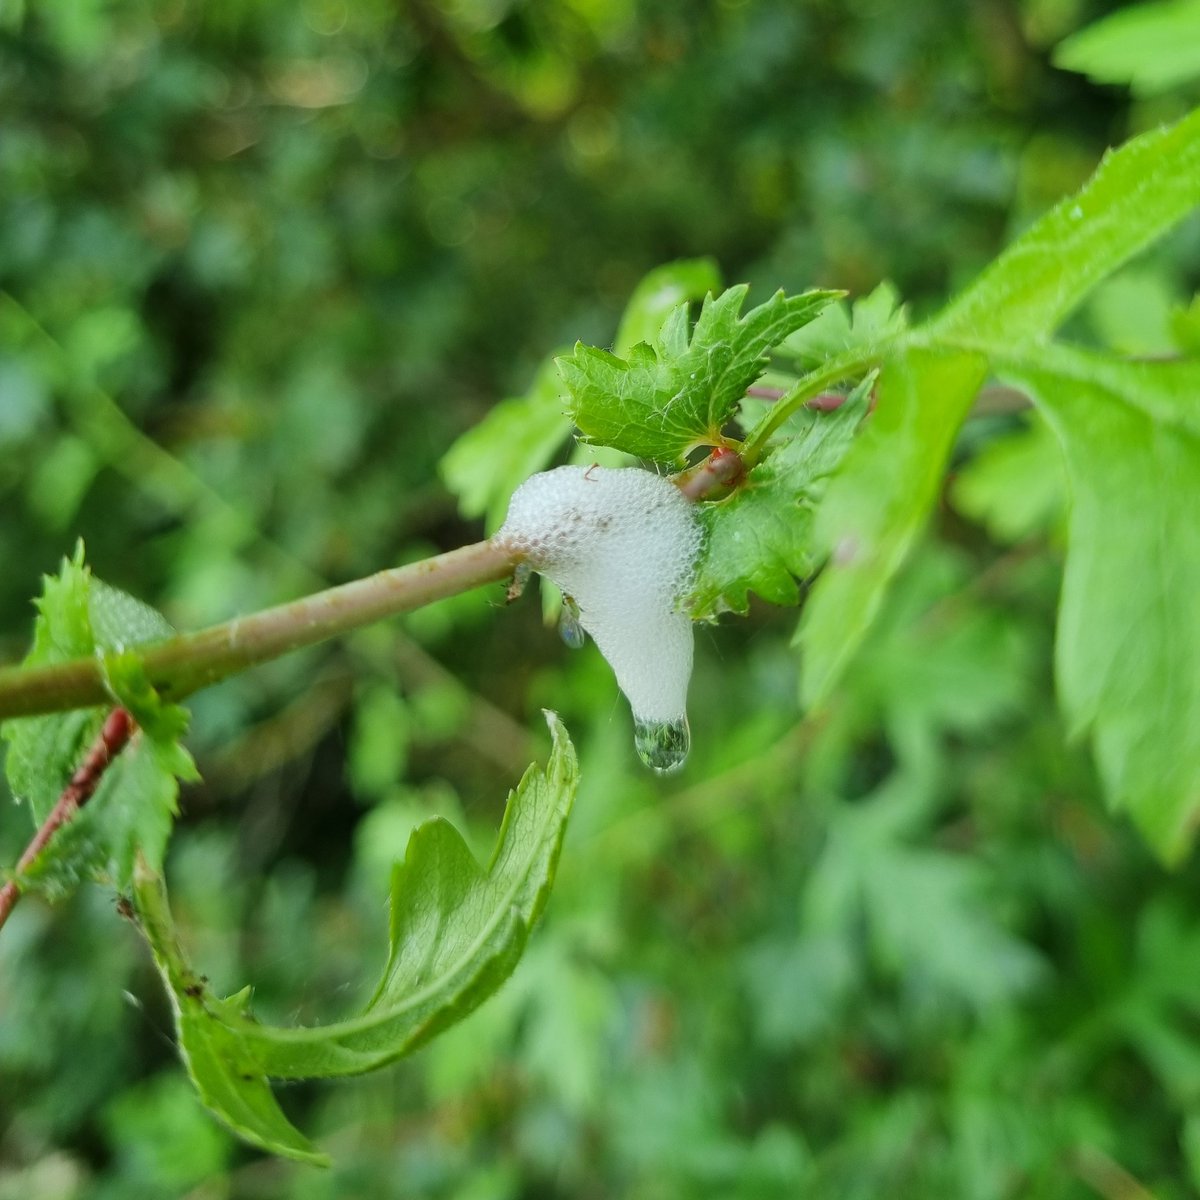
[446,105,1200,859]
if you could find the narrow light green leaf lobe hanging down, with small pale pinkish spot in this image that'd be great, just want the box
[798,347,985,703]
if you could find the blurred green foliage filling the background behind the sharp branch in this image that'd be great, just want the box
[0,0,1200,1200]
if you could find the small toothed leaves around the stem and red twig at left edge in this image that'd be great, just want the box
[0,546,198,899]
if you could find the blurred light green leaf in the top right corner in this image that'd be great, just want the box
[1054,0,1200,96]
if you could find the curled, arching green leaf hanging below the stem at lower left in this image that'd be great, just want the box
[136,713,578,1159]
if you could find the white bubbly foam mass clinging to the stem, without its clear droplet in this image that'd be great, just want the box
[496,467,701,722]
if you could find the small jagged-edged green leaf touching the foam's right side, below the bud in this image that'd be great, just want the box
[689,374,875,619]
